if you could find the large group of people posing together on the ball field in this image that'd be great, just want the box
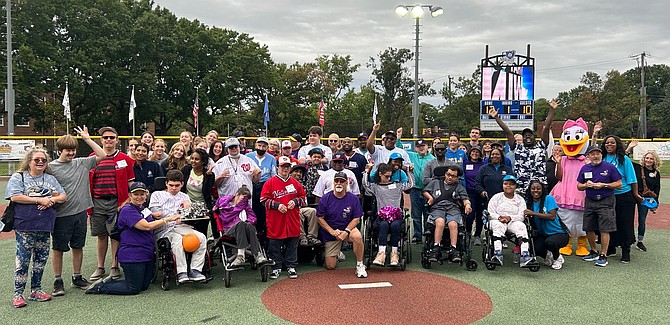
[6,107,660,307]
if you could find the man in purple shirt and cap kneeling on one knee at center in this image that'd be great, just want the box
[316,172,368,278]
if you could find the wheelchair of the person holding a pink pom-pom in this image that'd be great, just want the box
[363,200,412,271]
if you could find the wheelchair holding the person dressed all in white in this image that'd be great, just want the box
[482,210,540,272]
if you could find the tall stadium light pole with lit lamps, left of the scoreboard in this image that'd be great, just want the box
[395,4,444,138]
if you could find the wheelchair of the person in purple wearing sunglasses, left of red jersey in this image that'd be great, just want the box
[207,212,274,288]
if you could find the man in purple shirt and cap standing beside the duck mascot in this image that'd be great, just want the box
[577,146,621,267]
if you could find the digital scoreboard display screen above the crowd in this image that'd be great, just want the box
[480,66,535,131]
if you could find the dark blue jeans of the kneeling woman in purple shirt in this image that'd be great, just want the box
[100,261,154,295]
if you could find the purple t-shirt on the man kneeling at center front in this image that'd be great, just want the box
[316,191,363,242]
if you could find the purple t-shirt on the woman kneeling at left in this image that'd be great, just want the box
[117,204,154,263]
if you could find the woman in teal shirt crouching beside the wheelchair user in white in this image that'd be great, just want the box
[524,180,570,270]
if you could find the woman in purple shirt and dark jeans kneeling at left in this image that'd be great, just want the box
[86,182,180,295]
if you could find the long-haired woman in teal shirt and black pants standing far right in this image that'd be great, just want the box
[601,135,642,263]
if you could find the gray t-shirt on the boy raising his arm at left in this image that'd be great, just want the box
[49,156,96,218]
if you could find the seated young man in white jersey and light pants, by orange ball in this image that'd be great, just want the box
[149,169,207,283]
